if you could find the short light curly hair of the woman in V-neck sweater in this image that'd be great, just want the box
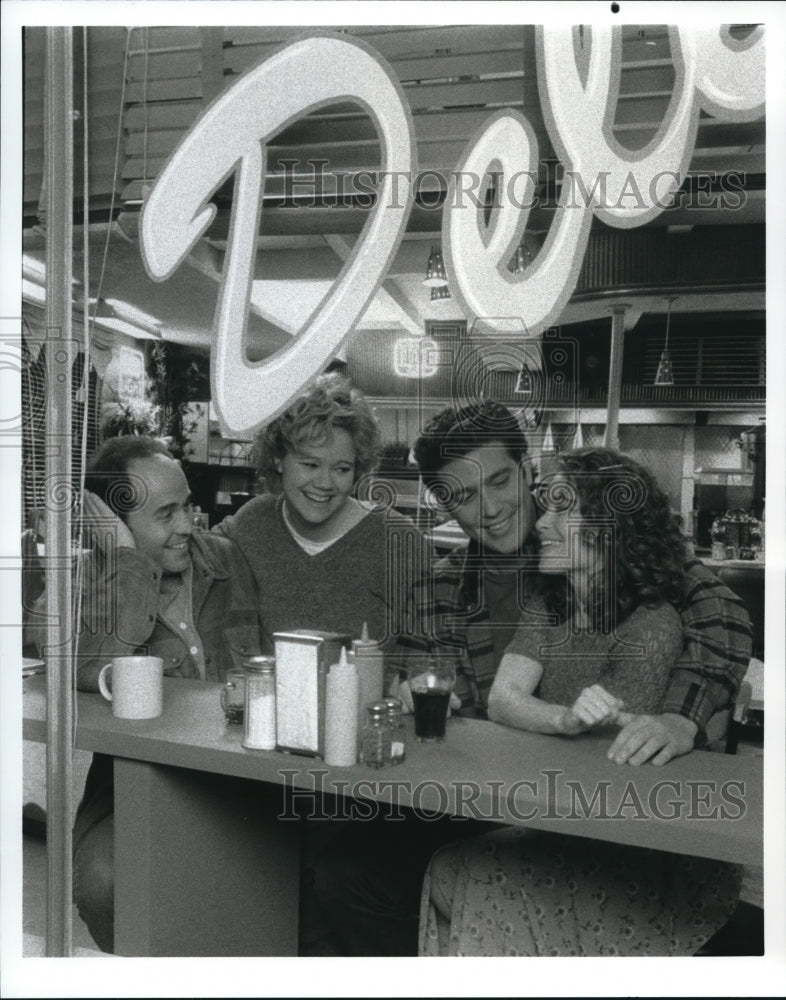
[254,373,382,493]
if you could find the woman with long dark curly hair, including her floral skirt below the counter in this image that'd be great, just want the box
[420,448,741,955]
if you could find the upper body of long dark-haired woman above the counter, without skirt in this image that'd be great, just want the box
[489,448,686,735]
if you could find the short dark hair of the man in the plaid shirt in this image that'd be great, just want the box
[413,399,527,488]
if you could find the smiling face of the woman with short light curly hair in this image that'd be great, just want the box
[279,428,356,533]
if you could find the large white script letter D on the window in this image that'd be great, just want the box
[139,35,414,435]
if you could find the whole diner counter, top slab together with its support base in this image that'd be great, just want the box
[23,676,763,956]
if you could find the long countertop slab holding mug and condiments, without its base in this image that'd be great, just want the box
[24,677,762,863]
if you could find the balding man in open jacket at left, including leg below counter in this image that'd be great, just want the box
[74,437,261,951]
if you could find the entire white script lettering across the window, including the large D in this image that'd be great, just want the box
[140,27,764,435]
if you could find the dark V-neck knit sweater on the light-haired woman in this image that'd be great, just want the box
[214,495,425,641]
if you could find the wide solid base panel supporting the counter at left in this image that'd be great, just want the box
[115,758,300,957]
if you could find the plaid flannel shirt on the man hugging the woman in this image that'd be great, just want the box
[390,545,751,746]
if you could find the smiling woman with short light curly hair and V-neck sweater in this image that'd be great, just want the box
[216,374,421,640]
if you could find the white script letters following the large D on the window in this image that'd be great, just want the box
[442,26,765,335]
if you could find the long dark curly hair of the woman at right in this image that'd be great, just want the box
[538,448,687,631]
